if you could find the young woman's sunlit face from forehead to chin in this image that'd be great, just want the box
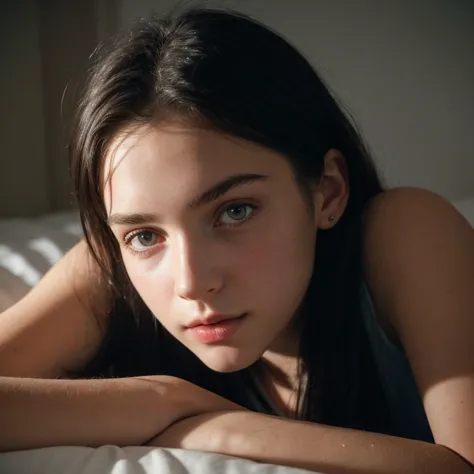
[104,124,317,372]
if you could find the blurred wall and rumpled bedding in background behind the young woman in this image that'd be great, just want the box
[0,0,474,310]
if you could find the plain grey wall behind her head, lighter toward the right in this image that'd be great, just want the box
[120,0,474,199]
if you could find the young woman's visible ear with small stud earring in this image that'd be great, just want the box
[314,149,349,229]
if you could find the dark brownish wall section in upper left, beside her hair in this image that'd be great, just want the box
[0,0,116,217]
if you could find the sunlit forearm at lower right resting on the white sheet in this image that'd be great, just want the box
[157,412,472,474]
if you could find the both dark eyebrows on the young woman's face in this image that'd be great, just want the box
[107,173,268,226]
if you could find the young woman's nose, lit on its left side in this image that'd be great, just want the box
[173,233,223,300]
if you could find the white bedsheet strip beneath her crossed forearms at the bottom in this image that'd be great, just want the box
[0,446,318,474]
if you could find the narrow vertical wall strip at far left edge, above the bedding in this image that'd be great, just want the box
[0,0,49,215]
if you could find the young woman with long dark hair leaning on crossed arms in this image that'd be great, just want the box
[0,4,474,473]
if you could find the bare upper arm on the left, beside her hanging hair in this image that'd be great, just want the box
[0,241,110,377]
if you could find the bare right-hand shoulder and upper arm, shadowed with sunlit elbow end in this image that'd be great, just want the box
[363,188,474,463]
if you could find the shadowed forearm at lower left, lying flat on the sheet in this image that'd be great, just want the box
[0,377,199,451]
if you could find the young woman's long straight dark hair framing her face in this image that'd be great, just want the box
[71,3,388,432]
